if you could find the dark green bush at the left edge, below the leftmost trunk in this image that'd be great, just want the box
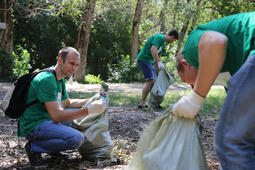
[0,48,14,81]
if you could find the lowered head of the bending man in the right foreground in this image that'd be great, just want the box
[176,50,198,88]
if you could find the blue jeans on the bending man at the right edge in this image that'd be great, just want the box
[215,55,255,170]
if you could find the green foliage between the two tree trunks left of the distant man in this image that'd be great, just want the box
[86,1,133,81]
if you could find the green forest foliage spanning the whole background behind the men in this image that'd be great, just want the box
[6,0,255,83]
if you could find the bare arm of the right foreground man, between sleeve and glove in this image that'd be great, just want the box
[194,31,227,97]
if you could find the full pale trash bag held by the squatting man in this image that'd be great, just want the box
[72,93,113,161]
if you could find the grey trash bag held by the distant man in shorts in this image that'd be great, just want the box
[149,69,174,108]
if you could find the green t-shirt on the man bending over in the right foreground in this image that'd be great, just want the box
[182,12,255,75]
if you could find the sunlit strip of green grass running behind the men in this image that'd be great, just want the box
[68,85,226,116]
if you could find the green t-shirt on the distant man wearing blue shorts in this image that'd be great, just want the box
[137,34,165,63]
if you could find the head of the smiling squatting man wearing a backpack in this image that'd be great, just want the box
[57,47,80,77]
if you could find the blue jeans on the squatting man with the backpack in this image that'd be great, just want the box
[26,121,84,153]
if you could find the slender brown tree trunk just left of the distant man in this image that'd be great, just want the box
[131,0,144,64]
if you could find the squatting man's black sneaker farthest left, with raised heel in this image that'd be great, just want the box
[25,142,48,168]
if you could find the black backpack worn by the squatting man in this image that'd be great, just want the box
[2,68,57,119]
